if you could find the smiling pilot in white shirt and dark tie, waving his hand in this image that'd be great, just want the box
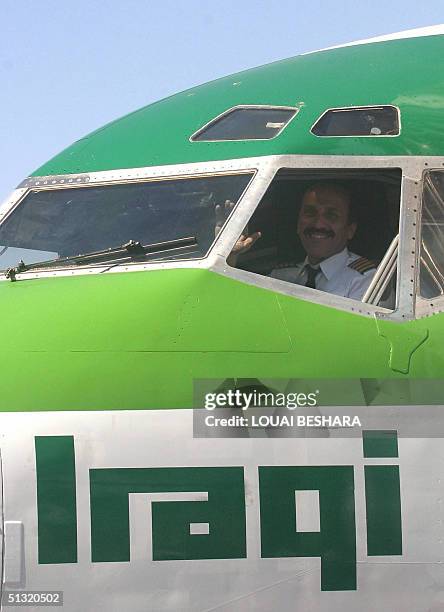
[227,182,376,300]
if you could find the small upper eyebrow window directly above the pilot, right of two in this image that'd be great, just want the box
[311,106,399,136]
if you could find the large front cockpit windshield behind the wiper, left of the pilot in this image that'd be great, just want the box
[0,172,253,270]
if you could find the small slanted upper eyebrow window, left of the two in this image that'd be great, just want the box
[191,106,298,142]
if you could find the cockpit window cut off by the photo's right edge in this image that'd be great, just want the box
[419,170,444,298]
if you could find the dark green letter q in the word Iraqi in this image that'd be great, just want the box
[259,465,356,591]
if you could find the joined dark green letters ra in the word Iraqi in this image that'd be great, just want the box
[90,467,246,561]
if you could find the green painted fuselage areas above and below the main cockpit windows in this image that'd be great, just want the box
[0,36,444,411]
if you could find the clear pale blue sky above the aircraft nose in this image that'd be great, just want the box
[0,0,444,202]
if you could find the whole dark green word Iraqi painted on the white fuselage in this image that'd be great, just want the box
[35,432,402,591]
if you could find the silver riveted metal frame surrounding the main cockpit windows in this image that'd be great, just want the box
[0,155,444,322]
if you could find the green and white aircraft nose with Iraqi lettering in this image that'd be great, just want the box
[0,26,444,612]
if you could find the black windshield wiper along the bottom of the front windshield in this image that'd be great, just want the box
[6,236,197,281]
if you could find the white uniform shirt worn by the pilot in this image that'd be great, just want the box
[270,248,376,300]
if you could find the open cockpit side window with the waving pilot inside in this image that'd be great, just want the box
[227,168,402,309]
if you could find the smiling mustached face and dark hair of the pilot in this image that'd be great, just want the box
[298,187,356,264]
